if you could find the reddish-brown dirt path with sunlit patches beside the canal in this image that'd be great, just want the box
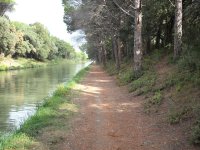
[58,66,198,150]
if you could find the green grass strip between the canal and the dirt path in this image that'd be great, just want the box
[0,68,89,150]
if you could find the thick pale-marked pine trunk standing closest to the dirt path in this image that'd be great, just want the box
[134,0,142,73]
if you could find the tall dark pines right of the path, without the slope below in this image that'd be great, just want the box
[63,0,200,72]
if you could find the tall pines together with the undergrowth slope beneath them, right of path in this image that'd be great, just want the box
[63,0,200,145]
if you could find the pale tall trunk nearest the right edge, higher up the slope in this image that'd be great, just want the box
[174,0,183,60]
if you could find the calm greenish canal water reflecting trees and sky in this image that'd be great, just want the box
[0,63,88,132]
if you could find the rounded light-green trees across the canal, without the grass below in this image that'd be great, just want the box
[0,17,83,61]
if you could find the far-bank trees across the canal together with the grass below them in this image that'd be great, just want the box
[0,17,87,71]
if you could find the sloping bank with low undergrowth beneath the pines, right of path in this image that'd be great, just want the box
[105,50,200,145]
